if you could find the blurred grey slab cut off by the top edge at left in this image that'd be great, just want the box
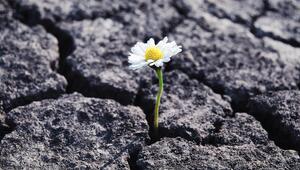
[11,0,146,22]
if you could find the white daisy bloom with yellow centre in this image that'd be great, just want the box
[128,37,182,70]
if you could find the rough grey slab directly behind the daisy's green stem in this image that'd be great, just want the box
[137,71,232,143]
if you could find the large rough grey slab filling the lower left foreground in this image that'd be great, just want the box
[0,93,148,169]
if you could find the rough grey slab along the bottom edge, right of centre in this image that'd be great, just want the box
[137,138,300,170]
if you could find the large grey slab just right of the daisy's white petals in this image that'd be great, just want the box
[170,13,300,110]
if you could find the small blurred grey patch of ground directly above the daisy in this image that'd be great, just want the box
[120,0,185,39]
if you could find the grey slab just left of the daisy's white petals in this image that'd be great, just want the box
[60,18,165,104]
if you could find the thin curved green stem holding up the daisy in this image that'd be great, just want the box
[154,67,164,135]
